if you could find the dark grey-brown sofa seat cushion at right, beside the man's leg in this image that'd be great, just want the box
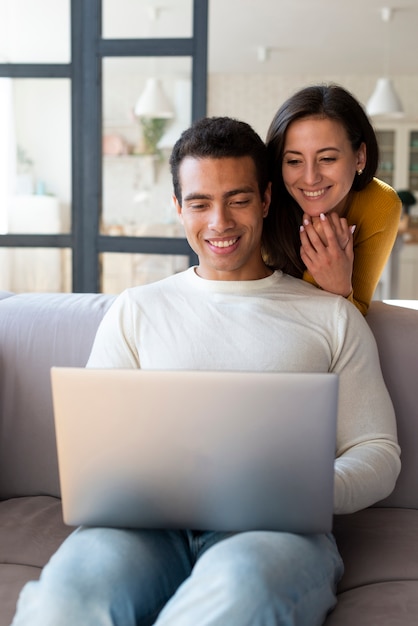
[325,507,418,626]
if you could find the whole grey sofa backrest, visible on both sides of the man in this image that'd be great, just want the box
[0,292,418,508]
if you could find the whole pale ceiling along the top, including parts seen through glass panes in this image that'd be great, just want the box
[0,0,418,79]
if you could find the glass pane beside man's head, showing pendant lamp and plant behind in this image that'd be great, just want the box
[101,58,191,237]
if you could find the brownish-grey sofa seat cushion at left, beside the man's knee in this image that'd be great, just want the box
[0,496,73,626]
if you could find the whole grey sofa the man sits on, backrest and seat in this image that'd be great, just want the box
[0,292,418,626]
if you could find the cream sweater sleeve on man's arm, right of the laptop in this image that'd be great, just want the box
[332,299,400,513]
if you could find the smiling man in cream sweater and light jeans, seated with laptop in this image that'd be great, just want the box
[13,118,400,626]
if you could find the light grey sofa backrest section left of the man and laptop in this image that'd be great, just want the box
[0,293,113,499]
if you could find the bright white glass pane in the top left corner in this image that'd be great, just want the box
[0,0,70,63]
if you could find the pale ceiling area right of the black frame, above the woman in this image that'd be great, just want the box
[209,0,418,76]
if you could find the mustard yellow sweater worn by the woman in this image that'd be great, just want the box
[303,178,402,315]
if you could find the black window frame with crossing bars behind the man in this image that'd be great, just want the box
[0,0,209,293]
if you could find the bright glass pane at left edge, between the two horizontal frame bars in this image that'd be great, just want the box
[0,78,71,234]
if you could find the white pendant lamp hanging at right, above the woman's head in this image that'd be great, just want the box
[366,7,404,118]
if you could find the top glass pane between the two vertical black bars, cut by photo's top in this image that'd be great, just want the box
[102,0,193,39]
